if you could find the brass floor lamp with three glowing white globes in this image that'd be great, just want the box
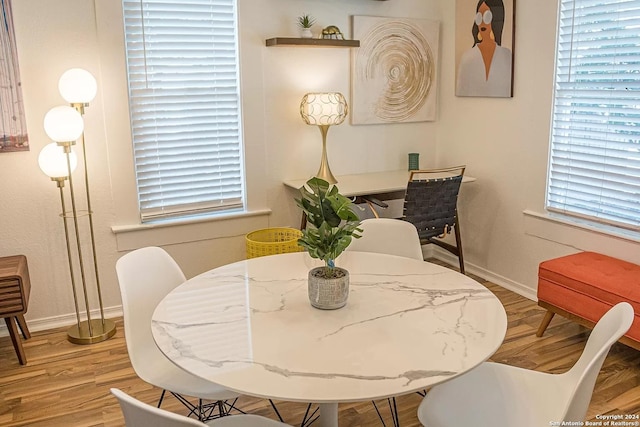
[38,68,116,344]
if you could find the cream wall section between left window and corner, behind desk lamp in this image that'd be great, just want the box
[248,0,440,226]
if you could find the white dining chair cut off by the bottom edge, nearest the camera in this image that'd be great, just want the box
[111,388,291,427]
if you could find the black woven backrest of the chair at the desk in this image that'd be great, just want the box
[403,175,462,239]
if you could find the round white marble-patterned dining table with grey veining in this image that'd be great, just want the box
[152,252,507,426]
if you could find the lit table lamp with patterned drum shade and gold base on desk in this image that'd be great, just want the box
[300,92,349,184]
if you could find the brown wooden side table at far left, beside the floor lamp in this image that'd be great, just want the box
[0,255,31,365]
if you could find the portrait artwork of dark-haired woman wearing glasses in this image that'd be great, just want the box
[455,0,516,98]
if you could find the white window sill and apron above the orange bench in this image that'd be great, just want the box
[523,210,640,251]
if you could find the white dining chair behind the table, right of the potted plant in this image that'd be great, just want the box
[346,218,424,261]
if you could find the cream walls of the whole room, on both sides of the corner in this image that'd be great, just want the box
[0,0,640,327]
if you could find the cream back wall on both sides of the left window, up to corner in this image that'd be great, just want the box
[0,0,439,329]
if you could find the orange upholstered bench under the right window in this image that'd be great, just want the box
[536,252,640,350]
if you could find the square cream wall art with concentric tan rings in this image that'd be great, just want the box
[351,16,440,124]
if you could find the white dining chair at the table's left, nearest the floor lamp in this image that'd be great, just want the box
[116,247,239,421]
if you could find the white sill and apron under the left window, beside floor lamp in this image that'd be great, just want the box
[111,209,271,251]
